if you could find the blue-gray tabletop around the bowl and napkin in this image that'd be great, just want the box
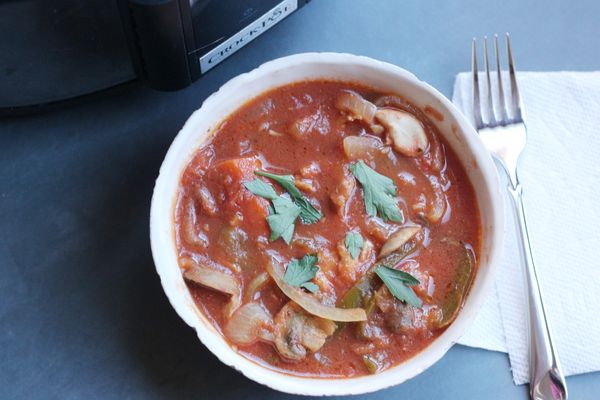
[0,0,600,400]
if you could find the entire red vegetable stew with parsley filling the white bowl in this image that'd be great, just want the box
[175,81,480,377]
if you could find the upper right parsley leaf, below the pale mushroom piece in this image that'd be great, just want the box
[350,160,404,222]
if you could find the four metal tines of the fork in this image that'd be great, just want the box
[471,33,522,130]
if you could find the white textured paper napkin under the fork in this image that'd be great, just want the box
[453,72,600,384]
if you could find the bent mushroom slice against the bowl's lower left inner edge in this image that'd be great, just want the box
[179,257,242,317]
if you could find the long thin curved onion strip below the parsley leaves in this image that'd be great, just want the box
[267,261,367,322]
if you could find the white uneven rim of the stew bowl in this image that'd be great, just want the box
[150,52,504,396]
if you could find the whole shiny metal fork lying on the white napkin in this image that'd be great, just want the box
[472,33,567,400]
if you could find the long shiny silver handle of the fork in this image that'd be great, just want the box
[508,182,567,400]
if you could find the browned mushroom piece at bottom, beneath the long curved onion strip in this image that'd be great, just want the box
[275,302,335,360]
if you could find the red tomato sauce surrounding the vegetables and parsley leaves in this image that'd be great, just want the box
[175,81,480,378]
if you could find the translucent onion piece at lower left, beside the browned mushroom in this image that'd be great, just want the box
[224,302,274,345]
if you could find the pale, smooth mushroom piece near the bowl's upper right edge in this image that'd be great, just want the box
[375,108,429,157]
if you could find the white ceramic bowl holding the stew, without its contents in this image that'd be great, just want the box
[150,53,504,395]
